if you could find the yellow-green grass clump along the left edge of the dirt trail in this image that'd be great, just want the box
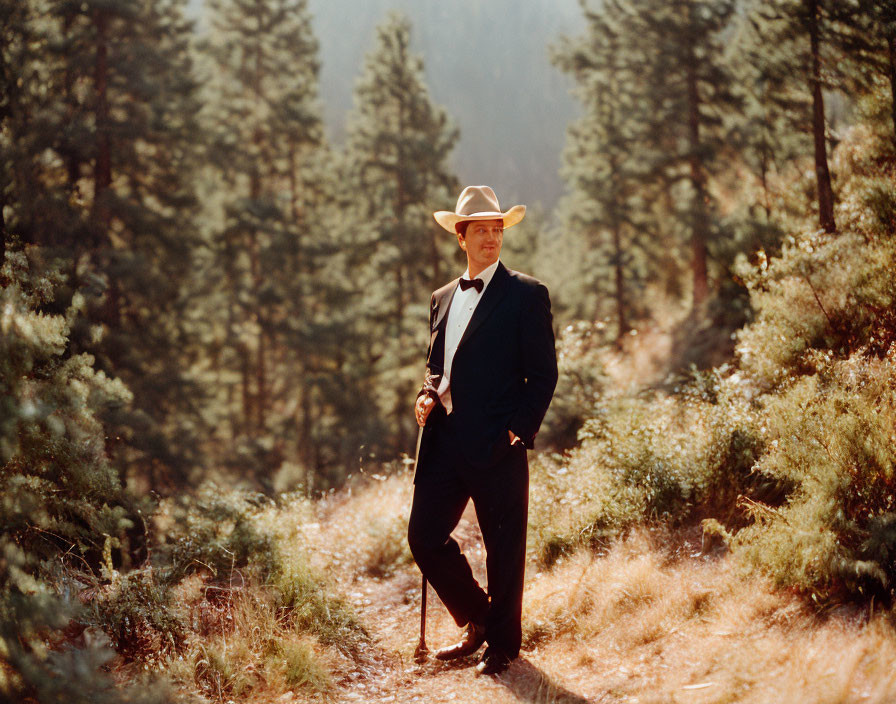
[158,498,366,704]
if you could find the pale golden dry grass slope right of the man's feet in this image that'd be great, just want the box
[525,533,896,704]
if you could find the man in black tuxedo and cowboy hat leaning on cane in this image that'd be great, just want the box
[408,186,557,674]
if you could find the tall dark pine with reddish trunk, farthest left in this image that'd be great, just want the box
[6,0,205,490]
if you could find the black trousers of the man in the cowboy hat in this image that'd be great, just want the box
[408,405,529,658]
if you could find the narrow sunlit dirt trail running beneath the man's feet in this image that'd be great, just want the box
[308,500,599,704]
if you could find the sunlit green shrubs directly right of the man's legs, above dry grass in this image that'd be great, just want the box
[530,370,763,566]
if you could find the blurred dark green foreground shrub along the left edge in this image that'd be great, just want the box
[0,248,173,704]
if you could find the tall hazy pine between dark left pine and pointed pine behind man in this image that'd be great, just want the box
[196,0,368,490]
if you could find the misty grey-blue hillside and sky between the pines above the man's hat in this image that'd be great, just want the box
[190,0,582,210]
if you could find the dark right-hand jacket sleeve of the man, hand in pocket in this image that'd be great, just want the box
[510,284,557,450]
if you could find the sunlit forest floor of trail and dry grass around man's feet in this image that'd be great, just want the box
[290,476,896,704]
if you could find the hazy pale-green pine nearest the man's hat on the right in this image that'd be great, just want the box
[553,2,655,342]
